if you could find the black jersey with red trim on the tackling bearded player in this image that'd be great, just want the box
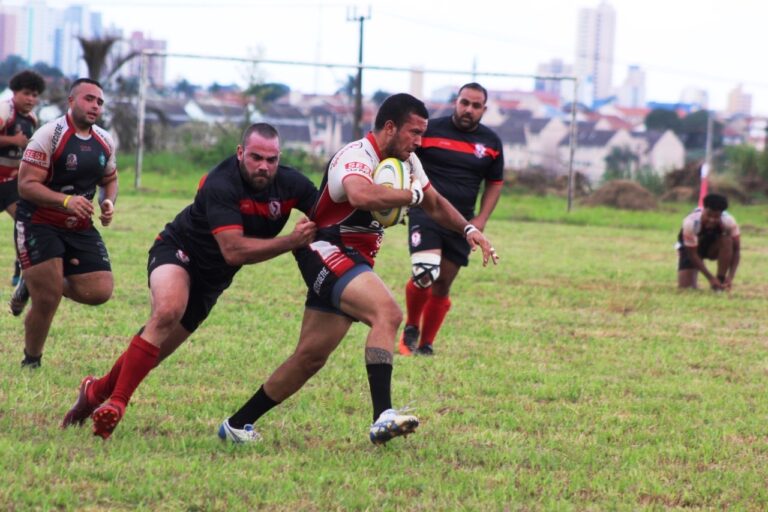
[159,156,317,277]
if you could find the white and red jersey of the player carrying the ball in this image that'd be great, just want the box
[312,133,430,265]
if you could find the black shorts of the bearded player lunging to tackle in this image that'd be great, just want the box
[147,238,232,332]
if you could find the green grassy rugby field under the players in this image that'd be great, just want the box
[0,159,768,511]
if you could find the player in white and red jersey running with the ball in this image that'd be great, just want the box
[219,94,496,444]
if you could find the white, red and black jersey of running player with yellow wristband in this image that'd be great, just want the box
[16,114,117,230]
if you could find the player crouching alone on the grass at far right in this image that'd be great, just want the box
[677,194,741,291]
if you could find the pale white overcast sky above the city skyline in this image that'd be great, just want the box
[18,0,768,115]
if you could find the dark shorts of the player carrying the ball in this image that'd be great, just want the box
[293,241,373,320]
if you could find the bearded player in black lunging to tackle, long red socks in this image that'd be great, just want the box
[61,123,317,439]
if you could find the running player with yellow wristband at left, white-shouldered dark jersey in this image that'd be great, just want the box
[10,78,117,368]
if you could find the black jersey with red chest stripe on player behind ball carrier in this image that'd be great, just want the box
[416,116,504,219]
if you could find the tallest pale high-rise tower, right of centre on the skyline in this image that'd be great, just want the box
[575,1,616,104]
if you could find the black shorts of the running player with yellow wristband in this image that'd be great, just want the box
[14,221,112,276]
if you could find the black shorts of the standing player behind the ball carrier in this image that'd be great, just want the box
[408,208,471,267]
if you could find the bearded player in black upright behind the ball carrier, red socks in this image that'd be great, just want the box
[398,82,504,356]
